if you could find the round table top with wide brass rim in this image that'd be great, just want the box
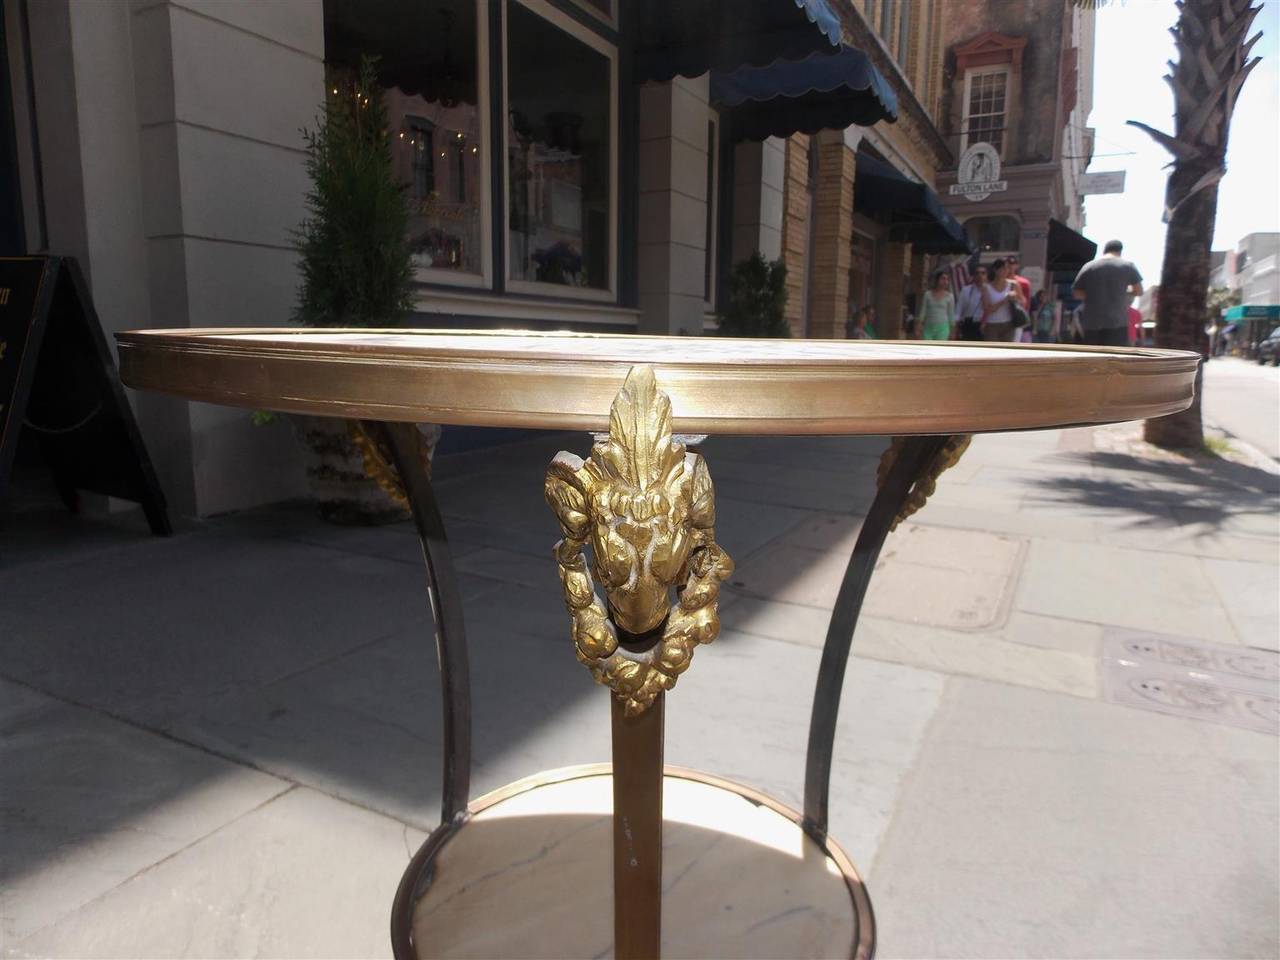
[116,328,1199,434]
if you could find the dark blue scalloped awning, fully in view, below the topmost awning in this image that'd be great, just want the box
[712,46,897,140]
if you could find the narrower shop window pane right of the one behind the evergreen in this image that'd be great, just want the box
[506,3,614,291]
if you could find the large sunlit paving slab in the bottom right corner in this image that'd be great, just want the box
[869,680,1280,957]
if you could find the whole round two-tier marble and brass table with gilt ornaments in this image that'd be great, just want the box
[118,329,1198,960]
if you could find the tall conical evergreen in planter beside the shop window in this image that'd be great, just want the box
[293,58,439,524]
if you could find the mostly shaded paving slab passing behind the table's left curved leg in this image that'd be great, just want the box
[170,601,609,828]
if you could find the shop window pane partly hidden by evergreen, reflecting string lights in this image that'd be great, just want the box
[325,0,489,283]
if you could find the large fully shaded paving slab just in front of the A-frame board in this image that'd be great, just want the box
[0,536,437,724]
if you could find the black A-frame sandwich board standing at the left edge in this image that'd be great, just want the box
[0,256,172,535]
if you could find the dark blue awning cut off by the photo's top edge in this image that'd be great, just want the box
[635,0,841,81]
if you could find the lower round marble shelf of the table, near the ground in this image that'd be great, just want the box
[393,764,874,959]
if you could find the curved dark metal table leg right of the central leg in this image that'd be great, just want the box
[804,436,955,840]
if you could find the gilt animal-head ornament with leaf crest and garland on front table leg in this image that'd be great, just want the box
[544,365,733,716]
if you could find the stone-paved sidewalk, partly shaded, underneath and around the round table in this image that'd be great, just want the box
[0,426,1280,957]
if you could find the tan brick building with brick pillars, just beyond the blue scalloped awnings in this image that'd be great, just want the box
[732,0,966,338]
